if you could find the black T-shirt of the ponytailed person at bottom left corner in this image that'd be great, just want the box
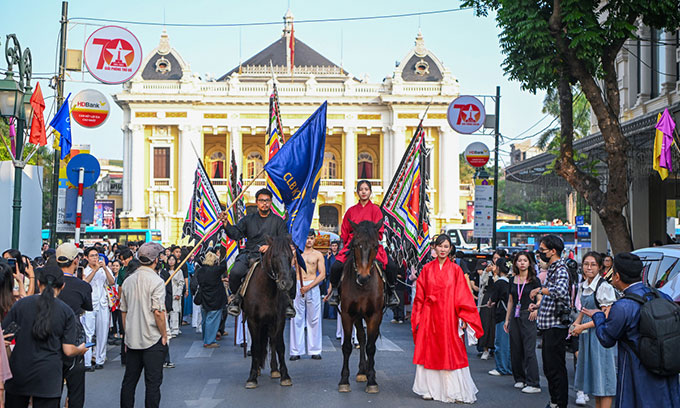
[2,295,76,398]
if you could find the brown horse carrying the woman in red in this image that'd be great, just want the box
[338,220,385,394]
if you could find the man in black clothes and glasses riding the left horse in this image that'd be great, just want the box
[220,188,295,318]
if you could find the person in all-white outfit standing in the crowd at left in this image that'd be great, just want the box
[82,248,115,371]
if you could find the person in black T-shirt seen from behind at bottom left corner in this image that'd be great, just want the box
[2,265,85,408]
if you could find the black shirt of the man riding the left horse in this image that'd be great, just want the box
[224,211,288,252]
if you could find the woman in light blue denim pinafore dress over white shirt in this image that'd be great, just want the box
[570,252,616,408]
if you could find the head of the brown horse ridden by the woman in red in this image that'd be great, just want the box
[350,219,383,286]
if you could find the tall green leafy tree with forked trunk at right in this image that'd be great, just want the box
[463,0,680,253]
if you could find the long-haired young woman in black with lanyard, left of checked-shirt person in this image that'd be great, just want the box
[503,252,542,394]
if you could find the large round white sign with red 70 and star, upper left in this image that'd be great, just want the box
[84,26,142,84]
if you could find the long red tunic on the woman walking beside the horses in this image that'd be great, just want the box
[411,259,484,370]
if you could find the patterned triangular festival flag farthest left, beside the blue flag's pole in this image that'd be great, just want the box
[182,160,230,255]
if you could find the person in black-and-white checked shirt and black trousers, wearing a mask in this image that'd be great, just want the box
[530,234,571,408]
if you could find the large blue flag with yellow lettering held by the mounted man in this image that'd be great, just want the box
[264,102,326,250]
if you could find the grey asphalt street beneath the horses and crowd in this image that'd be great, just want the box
[85,311,594,408]
